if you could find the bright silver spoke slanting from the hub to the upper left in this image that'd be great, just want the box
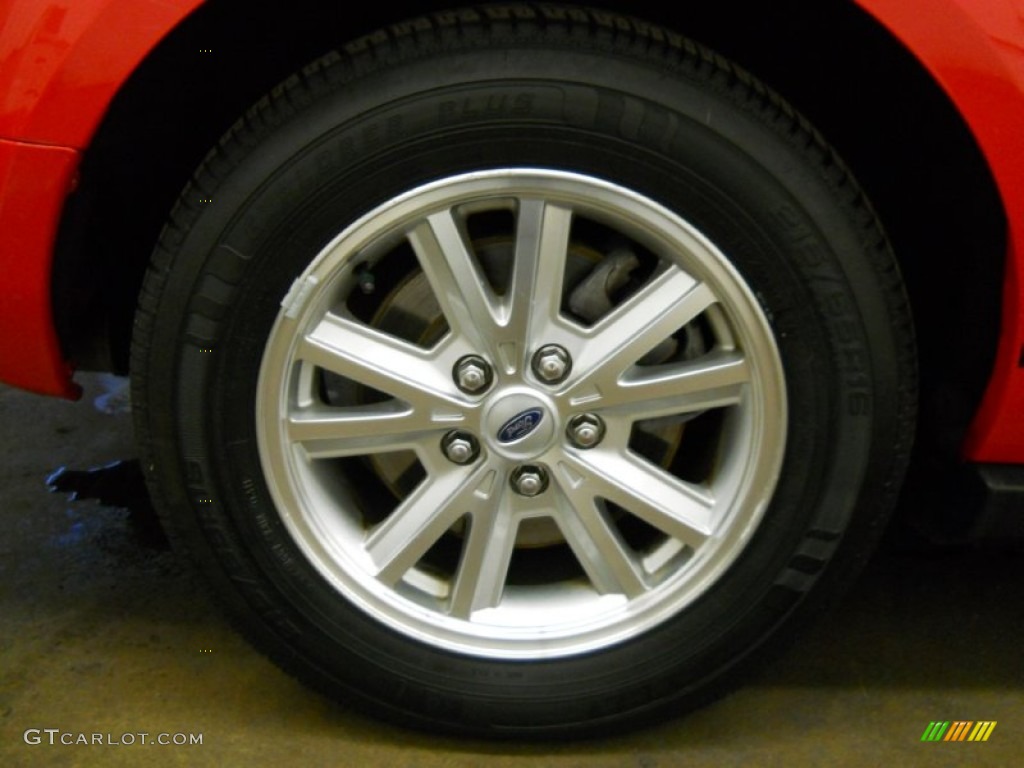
[296,312,458,409]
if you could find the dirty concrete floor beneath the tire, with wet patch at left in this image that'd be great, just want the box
[0,378,1024,768]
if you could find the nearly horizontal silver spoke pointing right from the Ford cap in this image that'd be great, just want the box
[588,351,751,421]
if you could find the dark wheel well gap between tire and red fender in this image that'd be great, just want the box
[54,0,1006,451]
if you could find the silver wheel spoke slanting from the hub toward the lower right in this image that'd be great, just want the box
[565,451,714,549]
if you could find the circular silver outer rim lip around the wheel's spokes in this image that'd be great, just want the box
[256,168,787,659]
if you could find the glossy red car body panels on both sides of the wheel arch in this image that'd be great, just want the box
[0,0,1024,464]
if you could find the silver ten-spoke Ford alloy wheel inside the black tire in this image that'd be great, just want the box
[256,169,786,659]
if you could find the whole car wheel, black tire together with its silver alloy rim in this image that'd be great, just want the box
[133,5,914,735]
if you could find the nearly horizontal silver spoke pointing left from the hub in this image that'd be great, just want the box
[288,400,449,459]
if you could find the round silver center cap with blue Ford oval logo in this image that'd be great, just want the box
[484,389,556,460]
